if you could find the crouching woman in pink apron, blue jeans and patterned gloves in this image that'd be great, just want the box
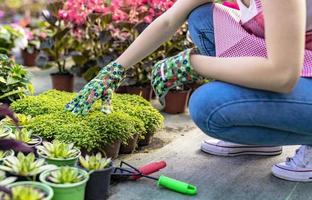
[66,0,312,182]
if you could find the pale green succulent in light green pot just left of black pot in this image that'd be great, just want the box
[48,166,84,184]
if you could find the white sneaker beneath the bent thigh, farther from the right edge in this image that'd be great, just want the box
[201,139,282,156]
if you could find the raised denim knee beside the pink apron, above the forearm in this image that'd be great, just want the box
[188,3,215,56]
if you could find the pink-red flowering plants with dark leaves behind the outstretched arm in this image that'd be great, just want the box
[58,0,187,85]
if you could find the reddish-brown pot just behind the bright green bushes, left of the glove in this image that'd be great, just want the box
[51,73,74,92]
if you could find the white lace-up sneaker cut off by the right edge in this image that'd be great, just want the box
[272,145,312,182]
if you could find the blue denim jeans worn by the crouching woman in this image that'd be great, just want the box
[188,4,312,145]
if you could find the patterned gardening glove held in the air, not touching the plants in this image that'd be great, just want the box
[151,49,203,105]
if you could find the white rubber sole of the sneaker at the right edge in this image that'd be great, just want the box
[272,165,312,182]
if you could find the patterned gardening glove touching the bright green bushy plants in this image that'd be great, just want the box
[65,62,125,115]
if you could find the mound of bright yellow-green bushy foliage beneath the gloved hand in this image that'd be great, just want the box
[11,90,164,151]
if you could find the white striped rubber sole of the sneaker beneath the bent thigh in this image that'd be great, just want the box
[201,141,282,157]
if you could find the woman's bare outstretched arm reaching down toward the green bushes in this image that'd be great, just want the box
[116,0,213,67]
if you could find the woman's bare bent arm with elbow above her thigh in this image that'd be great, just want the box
[191,0,306,93]
